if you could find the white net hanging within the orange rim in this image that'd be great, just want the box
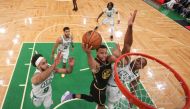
[113,52,187,109]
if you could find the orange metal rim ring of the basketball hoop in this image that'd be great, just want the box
[114,53,190,109]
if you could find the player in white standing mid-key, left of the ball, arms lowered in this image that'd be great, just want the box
[51,27,74,77]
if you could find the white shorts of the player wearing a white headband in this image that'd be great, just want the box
[30,91,53,109]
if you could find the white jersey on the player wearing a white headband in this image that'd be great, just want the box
[32,69,54,97]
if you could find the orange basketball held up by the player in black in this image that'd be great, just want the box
[82,30,102,49]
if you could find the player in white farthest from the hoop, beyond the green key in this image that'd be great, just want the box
[97,2,120,40]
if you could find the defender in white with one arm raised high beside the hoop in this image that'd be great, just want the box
[106,10,147,109]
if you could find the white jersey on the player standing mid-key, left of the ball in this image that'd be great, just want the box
[58,36,72,52]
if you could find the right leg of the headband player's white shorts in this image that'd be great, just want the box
[43,93,53,109]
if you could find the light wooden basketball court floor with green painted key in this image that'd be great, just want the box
[0,0,190,109]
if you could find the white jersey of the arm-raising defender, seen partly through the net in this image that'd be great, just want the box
[108,63,139,85]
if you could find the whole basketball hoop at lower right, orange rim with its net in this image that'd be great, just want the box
[114,53,190,109]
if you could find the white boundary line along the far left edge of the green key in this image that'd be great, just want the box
[1,42,24,109]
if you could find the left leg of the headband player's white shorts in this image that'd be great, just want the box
[30,92,44,107]
